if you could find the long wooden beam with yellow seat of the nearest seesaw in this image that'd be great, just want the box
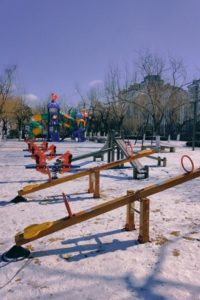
[15,168,200,246]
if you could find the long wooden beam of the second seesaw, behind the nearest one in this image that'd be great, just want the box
[18,150,155,196]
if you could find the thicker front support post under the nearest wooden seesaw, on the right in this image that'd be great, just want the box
[138,198,150,243]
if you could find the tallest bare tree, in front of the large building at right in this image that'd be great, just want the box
[128,52,191,135]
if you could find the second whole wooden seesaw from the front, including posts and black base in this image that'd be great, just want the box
[12,150,154,203]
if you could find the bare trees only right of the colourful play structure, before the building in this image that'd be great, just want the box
[82,52,192,139]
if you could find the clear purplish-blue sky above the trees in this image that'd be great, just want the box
[0,0,200,103]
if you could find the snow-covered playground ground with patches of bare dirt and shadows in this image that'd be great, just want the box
[0,141,200,300]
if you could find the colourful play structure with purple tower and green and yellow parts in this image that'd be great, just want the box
[26,93,88,142]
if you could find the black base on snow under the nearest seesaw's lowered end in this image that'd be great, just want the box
[1,245,30,262]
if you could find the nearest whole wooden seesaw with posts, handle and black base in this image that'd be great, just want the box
[4,162,200,259]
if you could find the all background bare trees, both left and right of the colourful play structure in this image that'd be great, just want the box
[0,51,195,140]
